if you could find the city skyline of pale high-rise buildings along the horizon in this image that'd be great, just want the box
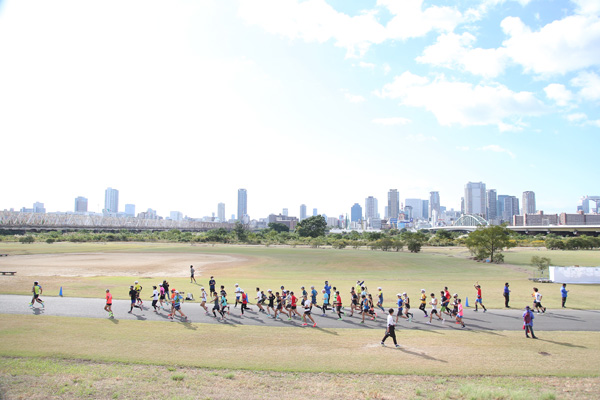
[11,182,600,231]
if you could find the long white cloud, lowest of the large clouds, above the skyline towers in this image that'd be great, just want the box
[376,71,545,131]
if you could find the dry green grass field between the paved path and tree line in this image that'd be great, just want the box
[0,243,600,309]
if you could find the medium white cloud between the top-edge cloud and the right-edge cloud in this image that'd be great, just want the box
[417,32,508,77]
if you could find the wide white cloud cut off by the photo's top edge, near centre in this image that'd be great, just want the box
[239,0,463,57]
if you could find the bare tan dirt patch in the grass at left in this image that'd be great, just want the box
[0,253,246,277]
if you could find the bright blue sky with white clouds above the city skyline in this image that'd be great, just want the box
[0,0,600,218]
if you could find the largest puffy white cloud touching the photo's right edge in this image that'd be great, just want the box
[500,15,600,75]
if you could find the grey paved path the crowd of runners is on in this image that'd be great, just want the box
[0,295,600,333]
